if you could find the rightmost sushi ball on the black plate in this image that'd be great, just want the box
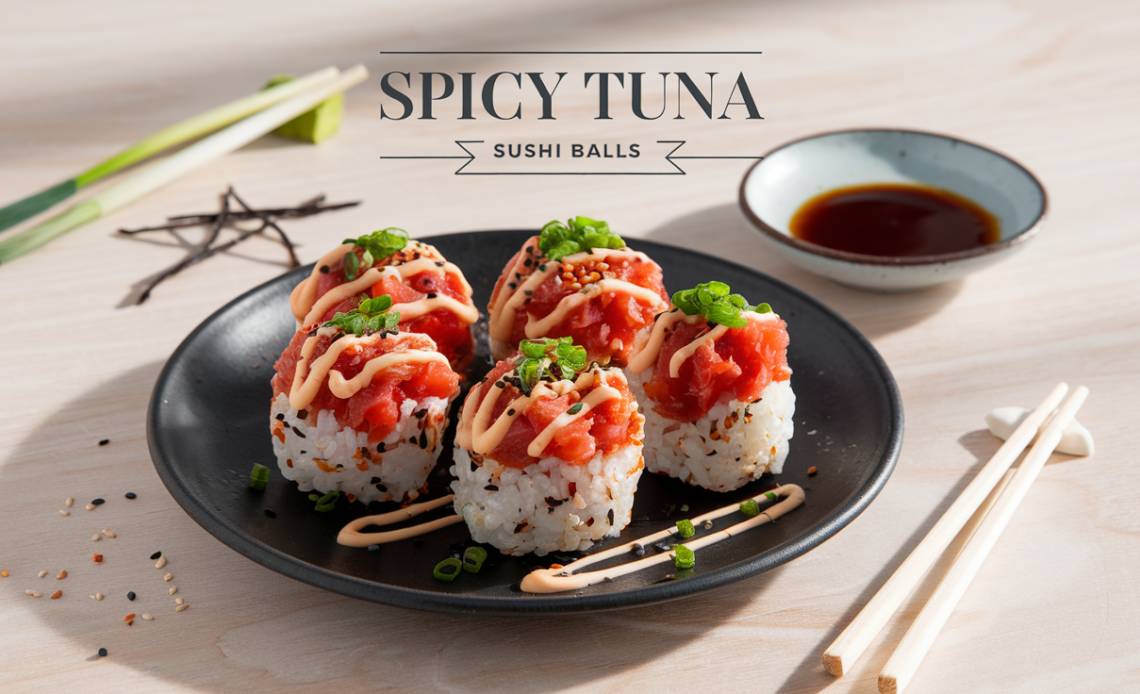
[628,283,796,491]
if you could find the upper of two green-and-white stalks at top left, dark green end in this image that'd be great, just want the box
[0,67,337,231]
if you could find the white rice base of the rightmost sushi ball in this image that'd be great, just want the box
[626,367,796,491]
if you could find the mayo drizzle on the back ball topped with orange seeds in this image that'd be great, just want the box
[489,243,666,342]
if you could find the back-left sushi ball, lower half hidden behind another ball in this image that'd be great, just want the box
[290,228,479,369]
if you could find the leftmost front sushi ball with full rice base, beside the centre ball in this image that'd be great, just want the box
[270,297,459,503]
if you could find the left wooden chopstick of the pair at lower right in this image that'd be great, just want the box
[823,383,1068,677]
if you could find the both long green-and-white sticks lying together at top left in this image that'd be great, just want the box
[0,65,368,264]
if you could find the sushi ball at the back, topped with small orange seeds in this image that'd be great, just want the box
[488,217,668,366]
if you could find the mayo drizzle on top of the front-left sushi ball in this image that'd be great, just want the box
[288,327,450,410]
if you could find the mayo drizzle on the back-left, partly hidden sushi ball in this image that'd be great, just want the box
[290,242,479,326]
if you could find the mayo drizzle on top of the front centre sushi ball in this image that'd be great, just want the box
[455,367,625,458]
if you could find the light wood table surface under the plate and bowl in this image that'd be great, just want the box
[0,0,1140,694]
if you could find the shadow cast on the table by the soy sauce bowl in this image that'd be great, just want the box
[645,203,967,340]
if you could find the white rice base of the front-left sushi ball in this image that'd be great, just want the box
[270,393,449,504]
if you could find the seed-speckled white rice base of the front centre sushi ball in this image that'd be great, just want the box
[451,437,643,556]
